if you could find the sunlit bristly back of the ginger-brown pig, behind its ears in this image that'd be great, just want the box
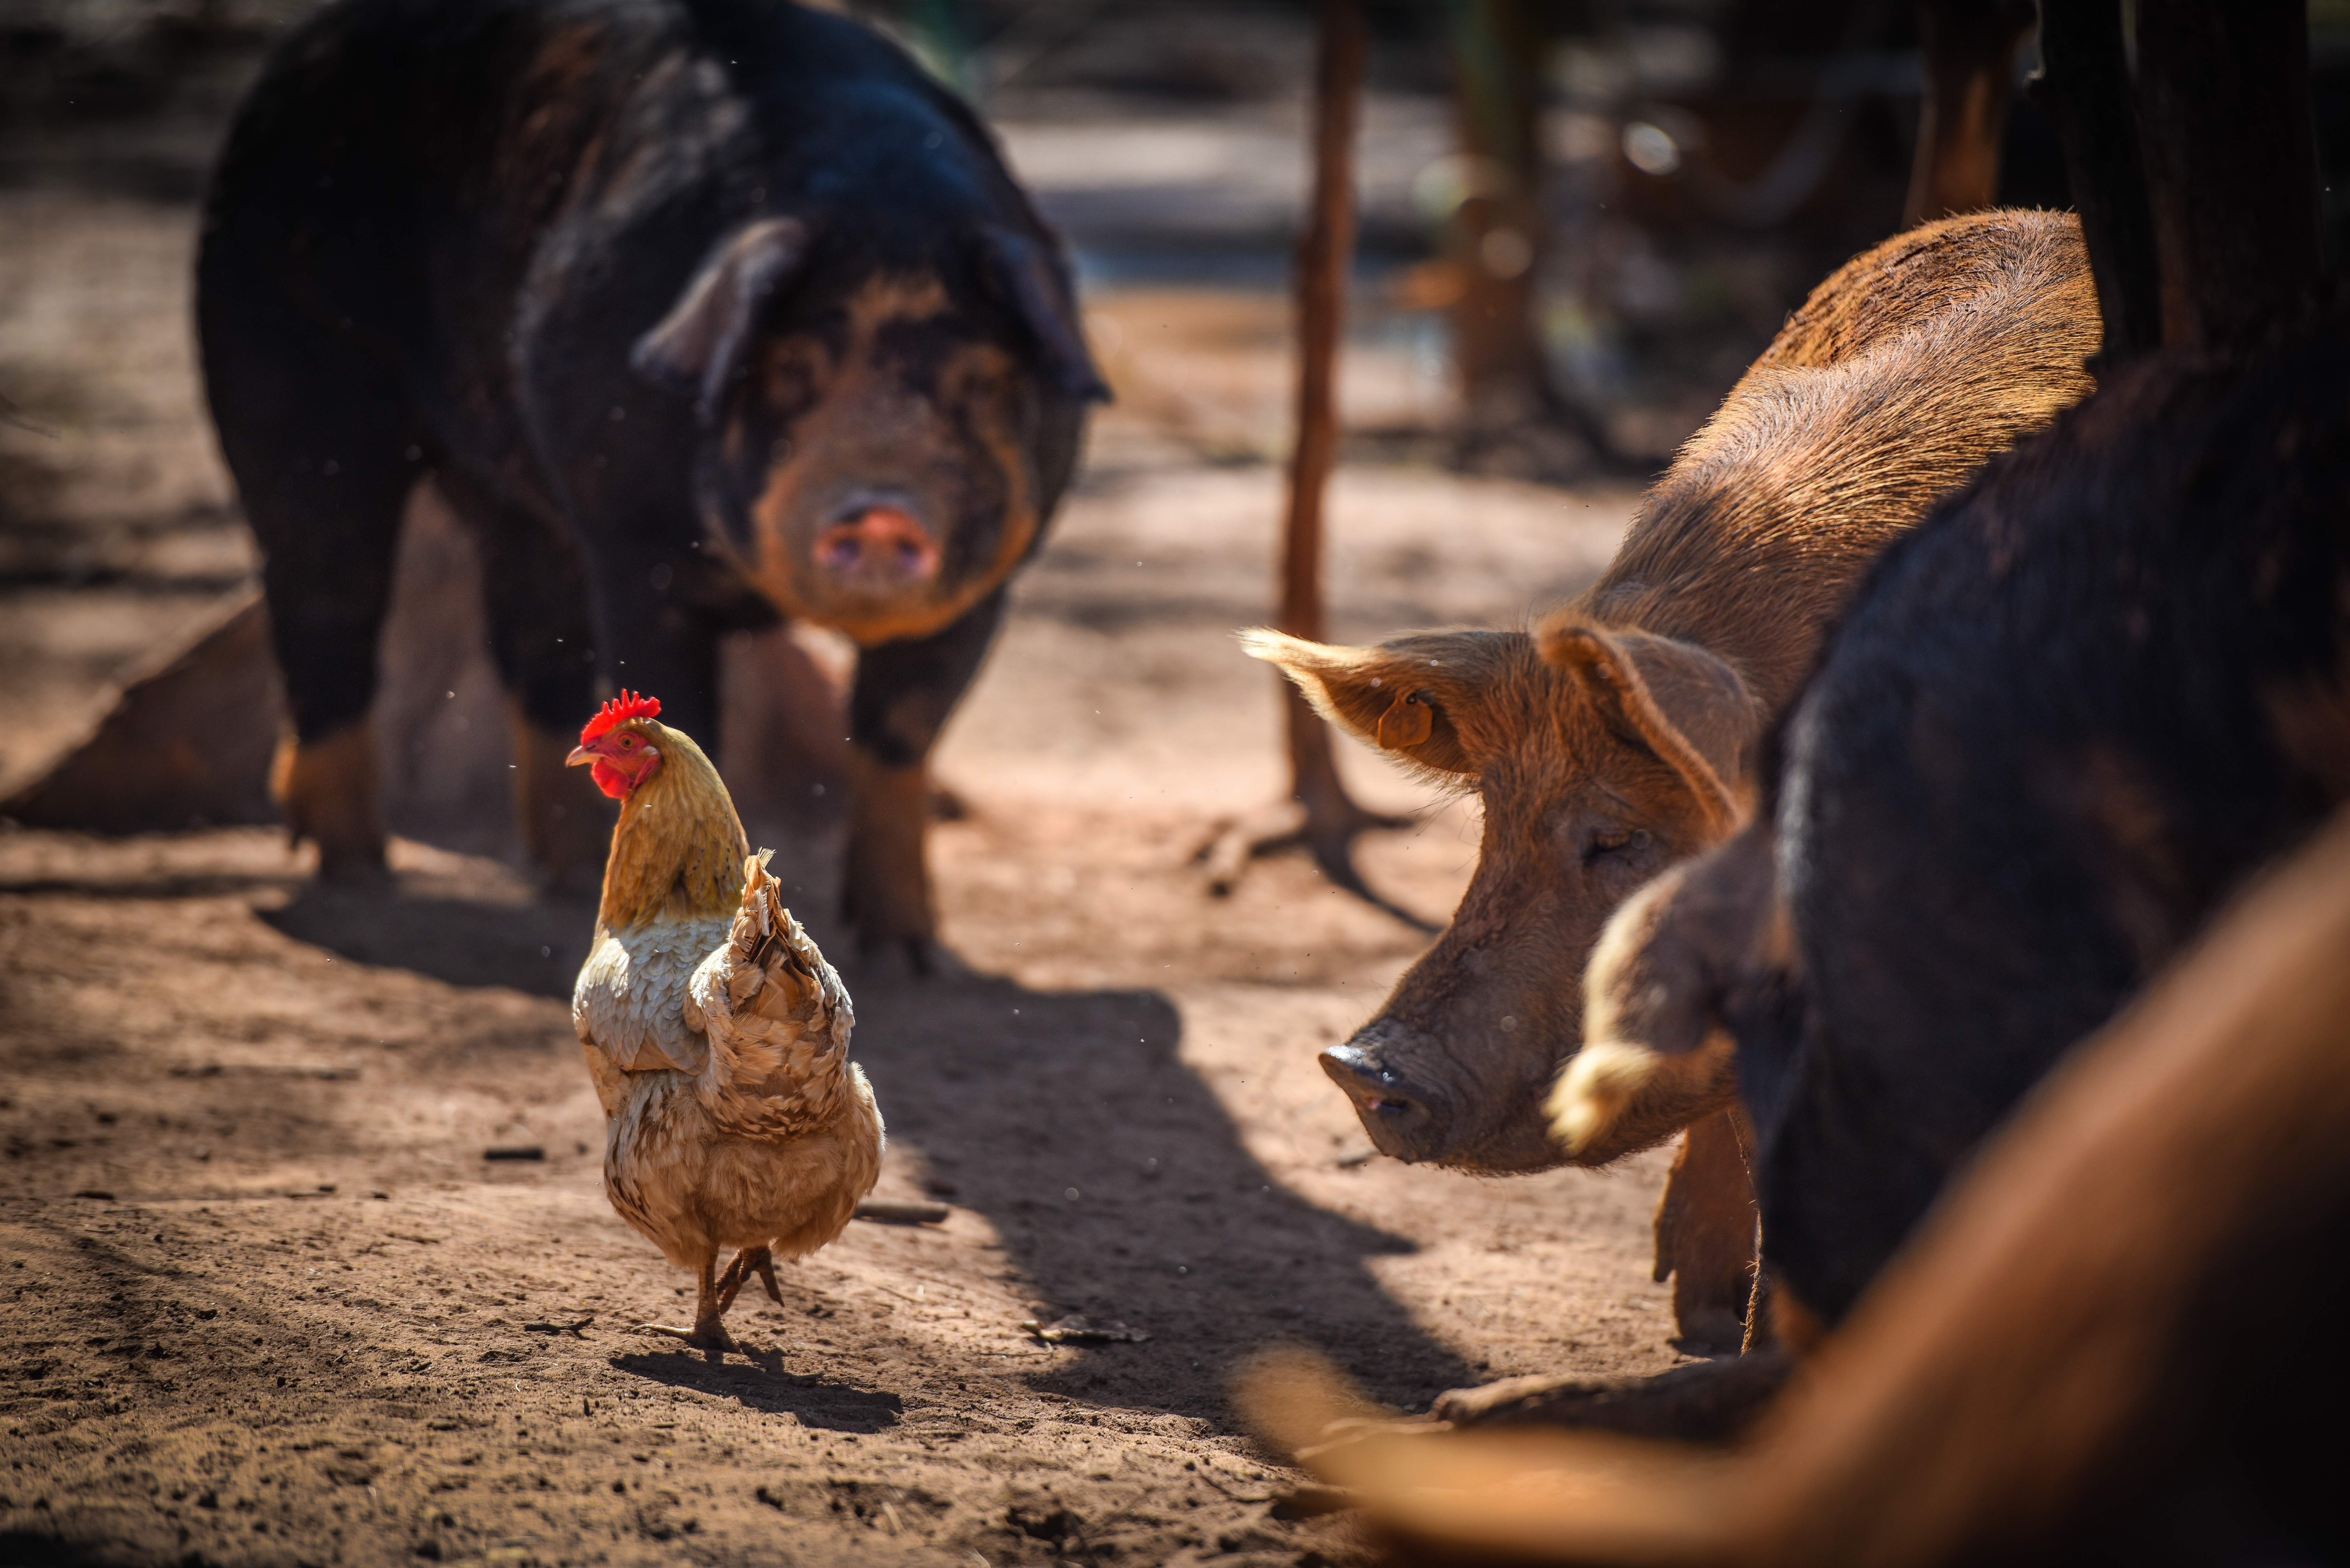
[1577,212,2101,715]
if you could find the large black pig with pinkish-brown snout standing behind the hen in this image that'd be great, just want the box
[197,0,1104,969]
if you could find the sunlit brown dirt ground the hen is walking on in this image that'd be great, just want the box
[0,175,1678,1566]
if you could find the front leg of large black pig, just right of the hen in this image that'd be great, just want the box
[841,588,1004,973]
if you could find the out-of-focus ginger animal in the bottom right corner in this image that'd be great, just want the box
[1239,816,2350,1568]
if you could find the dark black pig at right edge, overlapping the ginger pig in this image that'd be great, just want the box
[1553,315,2350,1342]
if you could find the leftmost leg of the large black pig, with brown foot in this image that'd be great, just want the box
[200,296,423,879]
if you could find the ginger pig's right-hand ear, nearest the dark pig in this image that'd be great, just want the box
[1539,621,1755,839]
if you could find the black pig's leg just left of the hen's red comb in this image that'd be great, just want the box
[435,470,611,893]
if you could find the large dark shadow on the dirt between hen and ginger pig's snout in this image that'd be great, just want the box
[853,983,1469,1420]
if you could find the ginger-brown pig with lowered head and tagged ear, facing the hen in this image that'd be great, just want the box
[1248,212,2098,1345]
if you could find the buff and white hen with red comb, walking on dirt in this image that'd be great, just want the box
[569,691,881,1359]
